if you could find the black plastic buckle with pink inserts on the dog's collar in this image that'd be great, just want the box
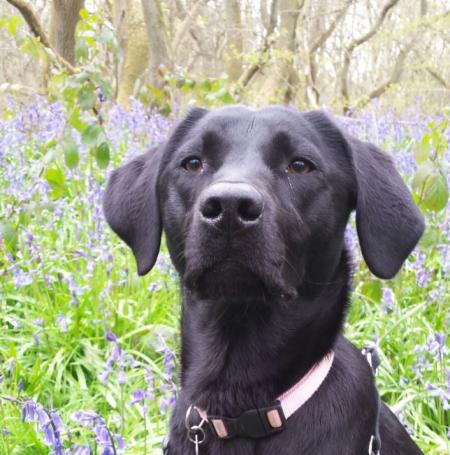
[208,401,286,439]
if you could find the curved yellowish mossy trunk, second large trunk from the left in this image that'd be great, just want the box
[114,0,149,108]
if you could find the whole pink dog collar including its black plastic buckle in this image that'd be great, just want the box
[190,351,334,439]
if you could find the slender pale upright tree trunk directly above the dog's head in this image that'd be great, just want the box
[225,0,244,81]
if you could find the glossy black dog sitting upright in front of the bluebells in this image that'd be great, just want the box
[104,106,424,455]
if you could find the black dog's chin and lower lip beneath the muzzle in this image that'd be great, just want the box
[184,260,297,303]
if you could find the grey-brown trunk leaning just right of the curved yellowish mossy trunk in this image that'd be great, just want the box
[142,0,171,87]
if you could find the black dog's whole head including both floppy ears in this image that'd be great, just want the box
[104,106,424,298]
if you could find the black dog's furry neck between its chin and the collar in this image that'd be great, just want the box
[181,250,350,414]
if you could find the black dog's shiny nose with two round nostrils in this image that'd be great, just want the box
[200,182,264,227]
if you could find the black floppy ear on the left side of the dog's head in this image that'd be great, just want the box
[103,145,164,275]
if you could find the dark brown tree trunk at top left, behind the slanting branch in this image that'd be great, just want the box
[50,0,84,65]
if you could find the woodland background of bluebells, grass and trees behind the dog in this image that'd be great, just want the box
[0,0,450,455]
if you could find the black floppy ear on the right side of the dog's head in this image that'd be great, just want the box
[347,137,425,279]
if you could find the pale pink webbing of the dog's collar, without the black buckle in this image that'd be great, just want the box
[200,351,334,439]
